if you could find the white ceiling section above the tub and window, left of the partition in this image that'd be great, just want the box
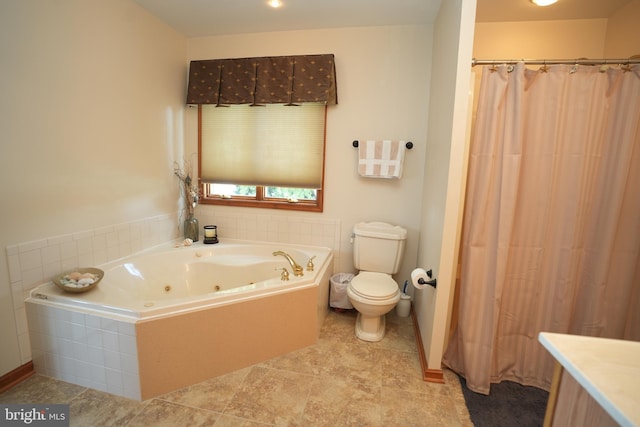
[134,0,442,37]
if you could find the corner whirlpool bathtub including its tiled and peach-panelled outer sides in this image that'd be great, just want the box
[25,240,333,400]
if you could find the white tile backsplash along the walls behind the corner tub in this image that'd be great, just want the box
[6,211,341,364]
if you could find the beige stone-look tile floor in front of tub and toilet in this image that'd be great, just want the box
[0,311,473,427]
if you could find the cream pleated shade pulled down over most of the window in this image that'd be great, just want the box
[200,103,326,189]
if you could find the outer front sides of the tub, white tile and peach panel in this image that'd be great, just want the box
[26,258,333,399]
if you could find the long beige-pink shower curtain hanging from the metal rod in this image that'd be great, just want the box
[444,64,640,394]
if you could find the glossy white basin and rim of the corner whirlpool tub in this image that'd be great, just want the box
[31,240,331,319]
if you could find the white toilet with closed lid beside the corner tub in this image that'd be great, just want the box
[347,222,407,341]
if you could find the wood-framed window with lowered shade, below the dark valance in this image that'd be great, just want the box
[198,103,326,212]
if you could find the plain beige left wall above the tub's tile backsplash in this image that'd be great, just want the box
[0,0,187,375]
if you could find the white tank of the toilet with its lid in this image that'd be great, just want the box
[353,222,407,274]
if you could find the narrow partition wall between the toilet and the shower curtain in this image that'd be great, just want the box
[414,0,476,376]
